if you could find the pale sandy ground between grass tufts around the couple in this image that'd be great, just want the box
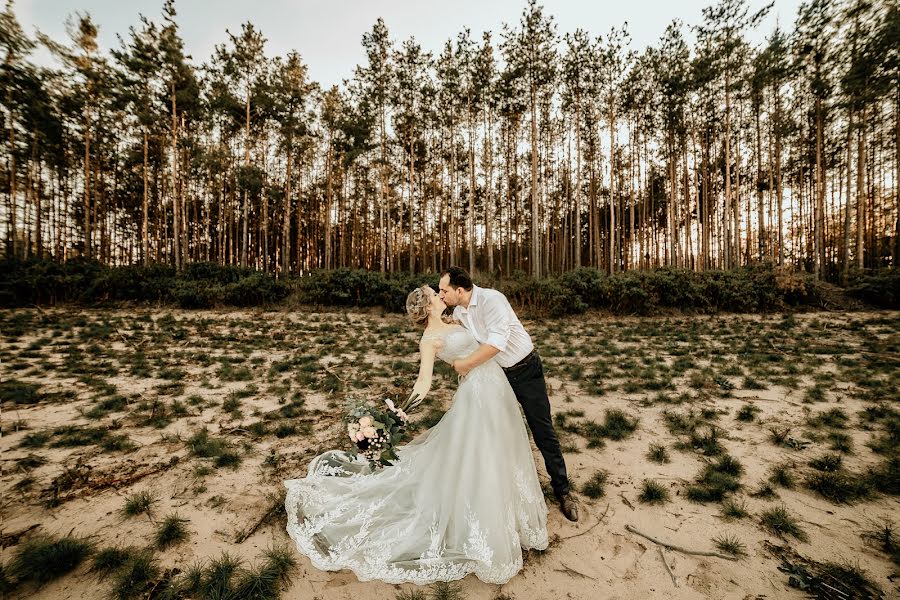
[0,309,900,600]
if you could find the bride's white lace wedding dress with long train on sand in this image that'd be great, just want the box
[284,326,547,585]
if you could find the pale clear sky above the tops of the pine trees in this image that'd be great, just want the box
[13,0,800,87]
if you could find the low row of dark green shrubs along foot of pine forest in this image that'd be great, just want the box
[0,259,856,316]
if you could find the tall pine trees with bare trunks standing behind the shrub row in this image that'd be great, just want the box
[0,0,900,283]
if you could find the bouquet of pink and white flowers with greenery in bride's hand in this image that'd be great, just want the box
[346,394,418,468]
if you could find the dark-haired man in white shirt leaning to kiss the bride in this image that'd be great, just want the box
[438,267,578,521]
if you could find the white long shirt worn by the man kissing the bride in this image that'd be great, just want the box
[453,285,534,367]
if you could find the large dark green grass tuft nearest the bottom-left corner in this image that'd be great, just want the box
[7,535,94,585]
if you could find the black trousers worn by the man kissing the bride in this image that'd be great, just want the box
[504,352,569,497]
